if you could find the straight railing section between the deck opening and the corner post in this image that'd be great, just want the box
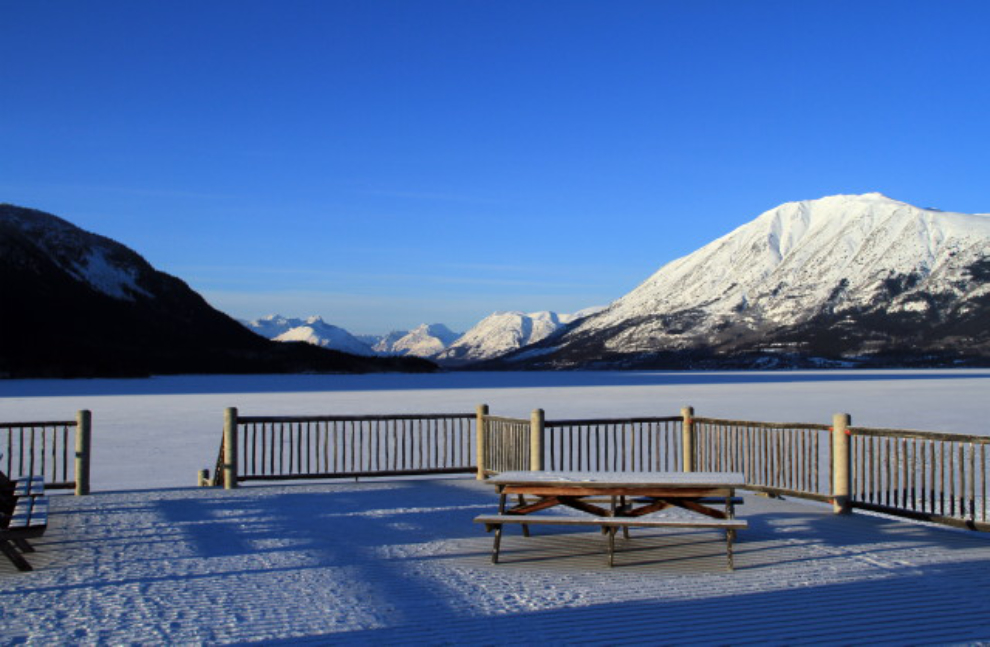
[212,409,476,487]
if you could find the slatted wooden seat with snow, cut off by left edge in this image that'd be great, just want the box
[0,472,48,571]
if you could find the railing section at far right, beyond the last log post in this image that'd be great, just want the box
[850,427,990,531]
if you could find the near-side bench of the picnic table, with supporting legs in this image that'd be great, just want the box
[474,512,749,571]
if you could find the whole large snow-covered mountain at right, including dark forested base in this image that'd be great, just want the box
[500,193,990,368]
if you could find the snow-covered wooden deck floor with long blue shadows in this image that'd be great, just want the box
[0,478,990,645]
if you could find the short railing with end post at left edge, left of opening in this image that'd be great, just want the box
[0,411,92,494]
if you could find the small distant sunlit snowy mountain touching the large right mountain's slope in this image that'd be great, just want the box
[436,312,572,364]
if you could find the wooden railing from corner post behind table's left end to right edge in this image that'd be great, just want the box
[478,407,990,531]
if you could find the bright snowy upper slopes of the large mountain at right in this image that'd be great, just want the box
[512,193,990,365]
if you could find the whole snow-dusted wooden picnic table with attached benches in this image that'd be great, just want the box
[475,471,747,570]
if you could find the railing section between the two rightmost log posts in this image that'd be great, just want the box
[691,418,833,501]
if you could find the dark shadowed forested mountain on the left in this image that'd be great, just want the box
[0,205,435,377]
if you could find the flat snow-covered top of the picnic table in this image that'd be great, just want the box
[488,470,746,488]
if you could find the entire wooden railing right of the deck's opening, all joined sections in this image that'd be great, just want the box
[201,405,990,531]
